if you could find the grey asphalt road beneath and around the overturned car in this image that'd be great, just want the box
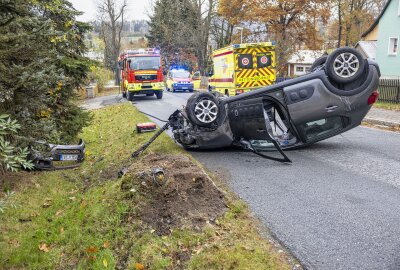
[99,93,400,270]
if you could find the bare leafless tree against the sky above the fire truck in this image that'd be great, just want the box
[97,0,127,70]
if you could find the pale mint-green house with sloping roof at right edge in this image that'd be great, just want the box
[356,0,400,77]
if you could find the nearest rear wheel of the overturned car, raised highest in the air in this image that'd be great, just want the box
[325,47,366,83]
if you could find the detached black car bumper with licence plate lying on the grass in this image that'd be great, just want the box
[29,139,85,171]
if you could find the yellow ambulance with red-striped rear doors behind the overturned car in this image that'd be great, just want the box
[209,42,276,96]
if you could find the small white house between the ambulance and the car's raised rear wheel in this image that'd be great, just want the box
[288,50,324,77]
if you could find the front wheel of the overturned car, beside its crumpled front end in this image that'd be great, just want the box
[186,92,219,127]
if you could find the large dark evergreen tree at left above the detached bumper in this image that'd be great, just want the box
[0,0,91,142]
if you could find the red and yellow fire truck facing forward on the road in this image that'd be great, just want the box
[119,48,164,101]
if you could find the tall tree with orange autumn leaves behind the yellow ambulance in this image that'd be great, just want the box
[219,0,329,72]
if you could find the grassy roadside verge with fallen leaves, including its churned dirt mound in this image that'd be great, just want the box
[0,103,293,269]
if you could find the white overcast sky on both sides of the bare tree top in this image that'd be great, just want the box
[69,0,152,22]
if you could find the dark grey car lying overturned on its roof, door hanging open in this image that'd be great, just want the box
[170,48,380,161]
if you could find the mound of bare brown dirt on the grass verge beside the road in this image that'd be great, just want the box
[122,154,227,235]
